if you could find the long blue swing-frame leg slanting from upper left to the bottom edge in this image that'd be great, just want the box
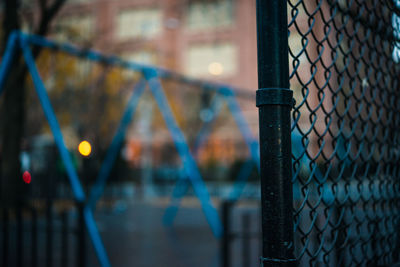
[19,35,110,267]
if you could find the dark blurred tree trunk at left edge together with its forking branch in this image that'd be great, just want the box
[0,0,66,204]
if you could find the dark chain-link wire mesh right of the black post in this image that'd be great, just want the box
[288,0,400,266]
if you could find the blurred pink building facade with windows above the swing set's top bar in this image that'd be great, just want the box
[48,0,257,90]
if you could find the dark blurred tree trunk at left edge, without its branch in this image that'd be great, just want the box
[0,0,25,204]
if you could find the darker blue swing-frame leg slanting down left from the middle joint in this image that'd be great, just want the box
[88,79,146,210]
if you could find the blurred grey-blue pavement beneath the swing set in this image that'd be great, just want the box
[88,199,219,267]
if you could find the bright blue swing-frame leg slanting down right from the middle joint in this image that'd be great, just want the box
[143,68,222,237]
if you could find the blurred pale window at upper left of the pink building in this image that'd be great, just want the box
[116,9,162,40]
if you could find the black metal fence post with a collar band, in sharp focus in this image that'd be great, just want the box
[256,0,297,266]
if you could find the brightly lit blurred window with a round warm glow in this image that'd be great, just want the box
[185,43,237,76]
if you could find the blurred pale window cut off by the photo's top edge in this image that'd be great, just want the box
[187,0,233,30]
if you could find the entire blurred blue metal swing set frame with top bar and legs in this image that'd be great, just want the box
[0,32,258,245]
